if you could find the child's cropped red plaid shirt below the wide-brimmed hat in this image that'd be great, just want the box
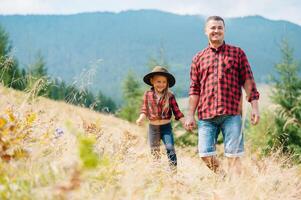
[141,88,184,120]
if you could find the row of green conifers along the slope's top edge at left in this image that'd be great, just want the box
[0,26,117,113]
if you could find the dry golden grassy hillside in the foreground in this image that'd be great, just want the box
[0,87,301,200]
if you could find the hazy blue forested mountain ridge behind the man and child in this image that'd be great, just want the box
[0,10,301,101]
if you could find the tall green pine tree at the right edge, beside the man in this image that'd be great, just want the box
[270,41,301,162]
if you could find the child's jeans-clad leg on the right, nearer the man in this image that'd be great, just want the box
[161,123,177,169]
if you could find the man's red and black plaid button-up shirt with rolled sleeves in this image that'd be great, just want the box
[189,43,259,119]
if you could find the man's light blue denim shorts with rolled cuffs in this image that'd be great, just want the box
[198,115,244,157]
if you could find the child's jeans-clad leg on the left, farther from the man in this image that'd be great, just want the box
[148,124,161,160]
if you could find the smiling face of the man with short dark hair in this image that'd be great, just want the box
[205,20,225,44]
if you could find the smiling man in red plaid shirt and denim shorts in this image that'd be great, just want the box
[185,16,259,174]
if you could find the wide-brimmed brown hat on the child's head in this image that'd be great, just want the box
[143,66,176,87]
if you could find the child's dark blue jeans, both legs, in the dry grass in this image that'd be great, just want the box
[148,123,177,167]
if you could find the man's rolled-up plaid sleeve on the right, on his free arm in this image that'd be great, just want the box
[239,50,259,102]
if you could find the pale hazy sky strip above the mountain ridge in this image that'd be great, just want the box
[0,0,301,25]
